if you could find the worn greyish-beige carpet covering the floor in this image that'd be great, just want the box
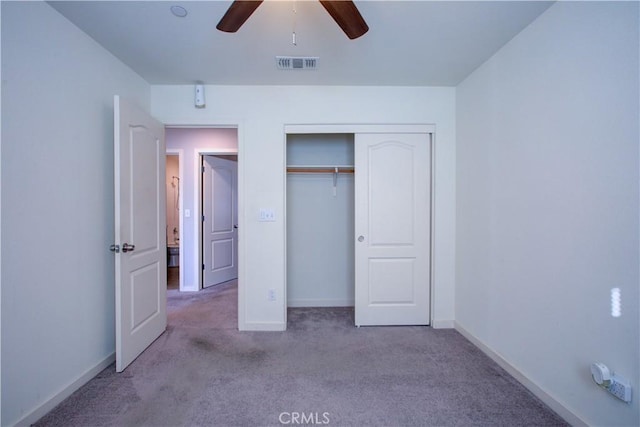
[37,283,567,427]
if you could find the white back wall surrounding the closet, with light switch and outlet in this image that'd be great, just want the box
[151,86,455,330]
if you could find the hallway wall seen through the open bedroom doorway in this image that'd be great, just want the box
[165,128,238,291]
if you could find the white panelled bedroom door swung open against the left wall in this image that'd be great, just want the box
[112,96,167,372]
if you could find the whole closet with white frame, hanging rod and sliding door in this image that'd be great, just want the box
[284,125,434,326]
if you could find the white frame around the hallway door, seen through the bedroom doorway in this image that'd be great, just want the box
[193,148,240,294]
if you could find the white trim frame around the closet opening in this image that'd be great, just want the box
[282,124,436,327]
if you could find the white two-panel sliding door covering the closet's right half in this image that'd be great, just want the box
[355,133,431,326]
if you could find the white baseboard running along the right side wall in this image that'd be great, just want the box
[454,322,589,427]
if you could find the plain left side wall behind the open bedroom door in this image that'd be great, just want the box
[2,2,149,425]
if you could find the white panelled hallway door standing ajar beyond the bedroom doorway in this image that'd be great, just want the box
[202,156,238,288]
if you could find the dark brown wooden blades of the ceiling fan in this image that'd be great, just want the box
[216,0,369,40]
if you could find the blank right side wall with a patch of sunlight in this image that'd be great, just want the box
[455,2,640,426]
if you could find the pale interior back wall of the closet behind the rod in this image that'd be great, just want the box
[286,134,355,307]
